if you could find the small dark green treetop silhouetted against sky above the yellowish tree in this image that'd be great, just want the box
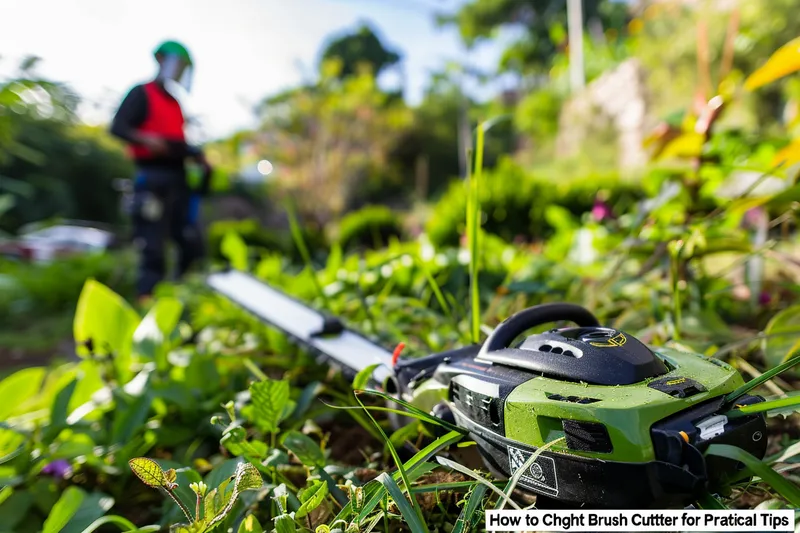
[322,23,401,78]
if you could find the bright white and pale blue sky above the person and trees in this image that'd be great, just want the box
[0,0,502,138]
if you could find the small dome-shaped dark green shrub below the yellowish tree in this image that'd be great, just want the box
[338,205,404,250]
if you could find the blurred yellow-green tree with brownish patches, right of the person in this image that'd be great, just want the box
[256,59,411,225]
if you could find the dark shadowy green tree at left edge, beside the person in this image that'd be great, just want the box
[0,58,130,231]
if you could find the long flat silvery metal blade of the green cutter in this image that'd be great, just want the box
[206,269,394,386]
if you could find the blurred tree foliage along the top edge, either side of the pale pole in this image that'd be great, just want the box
[439,0,628,74]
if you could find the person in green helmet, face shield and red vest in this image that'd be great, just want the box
[111,41,211,303]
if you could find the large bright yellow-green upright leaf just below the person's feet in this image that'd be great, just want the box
[73,279,141,381]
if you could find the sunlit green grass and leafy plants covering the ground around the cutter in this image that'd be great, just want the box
[0,133,800,533]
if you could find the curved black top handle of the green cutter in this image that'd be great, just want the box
[481,303,600,354]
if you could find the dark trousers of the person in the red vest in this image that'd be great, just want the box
[132,168,204,296]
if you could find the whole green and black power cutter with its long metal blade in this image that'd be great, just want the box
[208,270,767,509]
